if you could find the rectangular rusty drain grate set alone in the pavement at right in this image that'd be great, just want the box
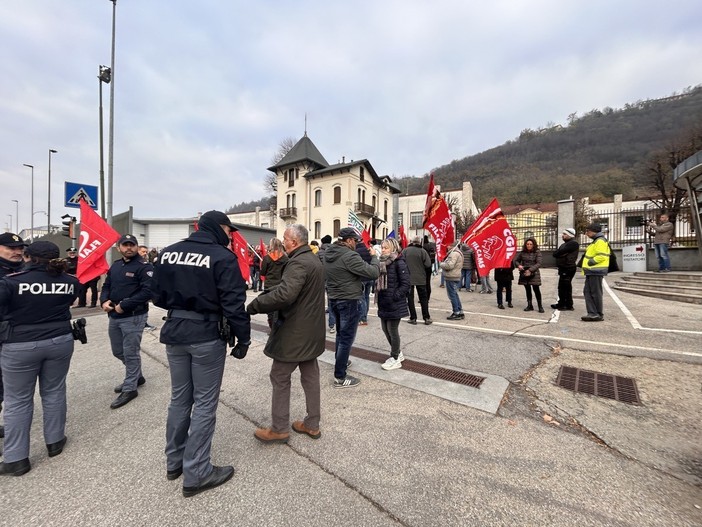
[556,366,641,405]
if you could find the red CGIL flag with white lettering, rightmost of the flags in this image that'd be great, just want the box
[461,199,517,276]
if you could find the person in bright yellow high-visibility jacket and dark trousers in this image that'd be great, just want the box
[580,223,611,322]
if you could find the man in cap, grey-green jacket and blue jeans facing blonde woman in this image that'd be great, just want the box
[324,227,380,388]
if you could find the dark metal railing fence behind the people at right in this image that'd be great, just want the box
[507,208,697,250]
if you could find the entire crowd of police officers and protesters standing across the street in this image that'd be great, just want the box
[0,211,670,497]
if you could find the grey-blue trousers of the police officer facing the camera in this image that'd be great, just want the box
[107,313,147,392]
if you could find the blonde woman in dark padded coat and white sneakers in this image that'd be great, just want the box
[375,238,410,370]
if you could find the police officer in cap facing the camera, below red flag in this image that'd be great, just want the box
[100,234,153,409]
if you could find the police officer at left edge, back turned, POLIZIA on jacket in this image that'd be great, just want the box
[0,241,78,476]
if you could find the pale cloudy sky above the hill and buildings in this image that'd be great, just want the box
[0,0,702,232]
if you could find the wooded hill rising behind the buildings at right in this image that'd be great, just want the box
[396,85,702,207]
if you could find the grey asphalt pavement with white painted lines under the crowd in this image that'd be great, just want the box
[0,269,702,527]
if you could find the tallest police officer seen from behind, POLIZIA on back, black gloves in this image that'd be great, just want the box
[153,210,251,497]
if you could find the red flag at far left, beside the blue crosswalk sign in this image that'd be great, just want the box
[76,199,119,284]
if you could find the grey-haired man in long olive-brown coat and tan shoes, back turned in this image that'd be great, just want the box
[246,224,325,443]
